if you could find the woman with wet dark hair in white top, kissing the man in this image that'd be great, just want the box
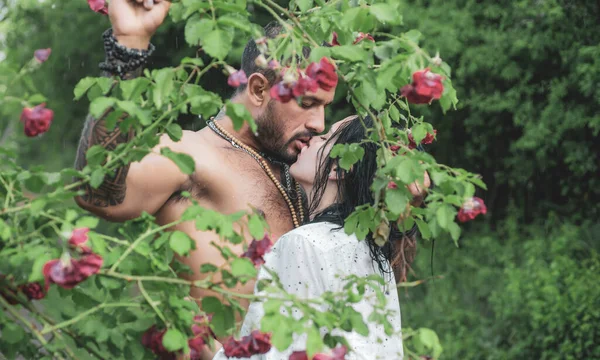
[215,116,429,360]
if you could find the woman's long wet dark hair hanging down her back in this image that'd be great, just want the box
[308,117,416,282]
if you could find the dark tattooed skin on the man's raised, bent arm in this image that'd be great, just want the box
[75,67,142,207]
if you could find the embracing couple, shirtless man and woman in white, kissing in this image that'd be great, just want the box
[76,0,429,359]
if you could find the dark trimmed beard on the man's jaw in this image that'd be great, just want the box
[256,99,312,164]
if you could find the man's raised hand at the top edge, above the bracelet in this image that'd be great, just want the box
[108,0,171,49]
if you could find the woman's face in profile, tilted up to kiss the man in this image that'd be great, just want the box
[290,116,354,189]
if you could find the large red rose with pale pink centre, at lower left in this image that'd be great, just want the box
[42,254,102,290]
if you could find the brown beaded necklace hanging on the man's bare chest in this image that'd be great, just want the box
[206,120,304,228]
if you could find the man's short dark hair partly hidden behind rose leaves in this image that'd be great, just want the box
[233,21,310,96]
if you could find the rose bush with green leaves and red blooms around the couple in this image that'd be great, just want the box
[0,0,485,359]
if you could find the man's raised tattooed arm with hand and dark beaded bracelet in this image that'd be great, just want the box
[75,0,185,221]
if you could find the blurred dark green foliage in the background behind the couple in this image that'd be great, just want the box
[0,0,600,359]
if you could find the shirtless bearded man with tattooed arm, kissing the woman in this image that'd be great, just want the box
[76,0,335,304]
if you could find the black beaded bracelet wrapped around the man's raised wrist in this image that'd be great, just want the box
[99,29,155,78]
